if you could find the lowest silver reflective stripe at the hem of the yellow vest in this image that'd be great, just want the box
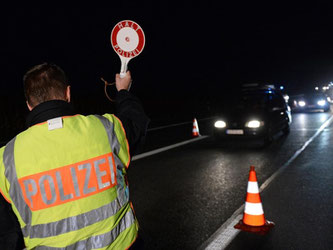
[35,210,135,250]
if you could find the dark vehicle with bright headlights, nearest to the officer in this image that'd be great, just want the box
[213,84,292,144]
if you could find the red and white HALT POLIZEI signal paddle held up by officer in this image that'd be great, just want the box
[111,20,145,78]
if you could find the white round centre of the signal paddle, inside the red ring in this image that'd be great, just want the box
[117,27,139,52]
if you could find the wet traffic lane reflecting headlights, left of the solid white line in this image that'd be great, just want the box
[129,113,331,249]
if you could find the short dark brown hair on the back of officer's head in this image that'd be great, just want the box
[23,63,68,107]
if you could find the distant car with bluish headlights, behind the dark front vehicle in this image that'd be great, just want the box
[289,92,331,112]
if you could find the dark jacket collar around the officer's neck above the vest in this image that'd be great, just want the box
[26,100,75,127]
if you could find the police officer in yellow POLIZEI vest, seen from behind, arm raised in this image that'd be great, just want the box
[0,63,149,249]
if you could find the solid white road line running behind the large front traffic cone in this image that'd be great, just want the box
[199,116,333,250]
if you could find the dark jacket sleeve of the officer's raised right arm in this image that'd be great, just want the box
[115,90,150,155]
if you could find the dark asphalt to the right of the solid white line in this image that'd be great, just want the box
[226,115,333,250]
